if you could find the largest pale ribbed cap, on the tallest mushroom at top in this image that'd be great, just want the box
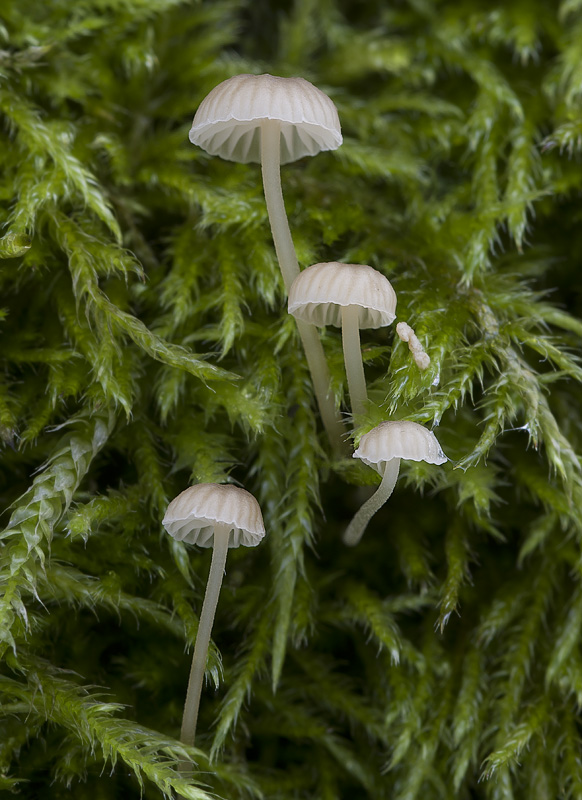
[190,74,342,164]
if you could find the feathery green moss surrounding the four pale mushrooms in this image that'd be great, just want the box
[0,0,582,800]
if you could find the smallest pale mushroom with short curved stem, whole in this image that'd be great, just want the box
[344,421,447,546]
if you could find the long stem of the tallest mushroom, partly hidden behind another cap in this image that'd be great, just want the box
[261,120,346,454]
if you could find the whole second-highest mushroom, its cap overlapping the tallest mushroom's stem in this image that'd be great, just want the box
[288,261,396,417]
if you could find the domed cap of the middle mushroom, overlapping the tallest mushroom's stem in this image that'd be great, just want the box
[288,261,396,328]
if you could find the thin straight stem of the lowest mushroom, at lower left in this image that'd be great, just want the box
[180,524,232,745]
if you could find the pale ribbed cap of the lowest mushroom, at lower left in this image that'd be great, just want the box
[162,483,265,547]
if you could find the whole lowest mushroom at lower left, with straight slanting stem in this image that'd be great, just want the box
[162,483,265,745]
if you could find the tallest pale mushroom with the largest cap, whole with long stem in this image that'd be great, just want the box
[190,75,345,451]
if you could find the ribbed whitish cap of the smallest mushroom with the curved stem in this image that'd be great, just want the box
[354,421,447,474]
